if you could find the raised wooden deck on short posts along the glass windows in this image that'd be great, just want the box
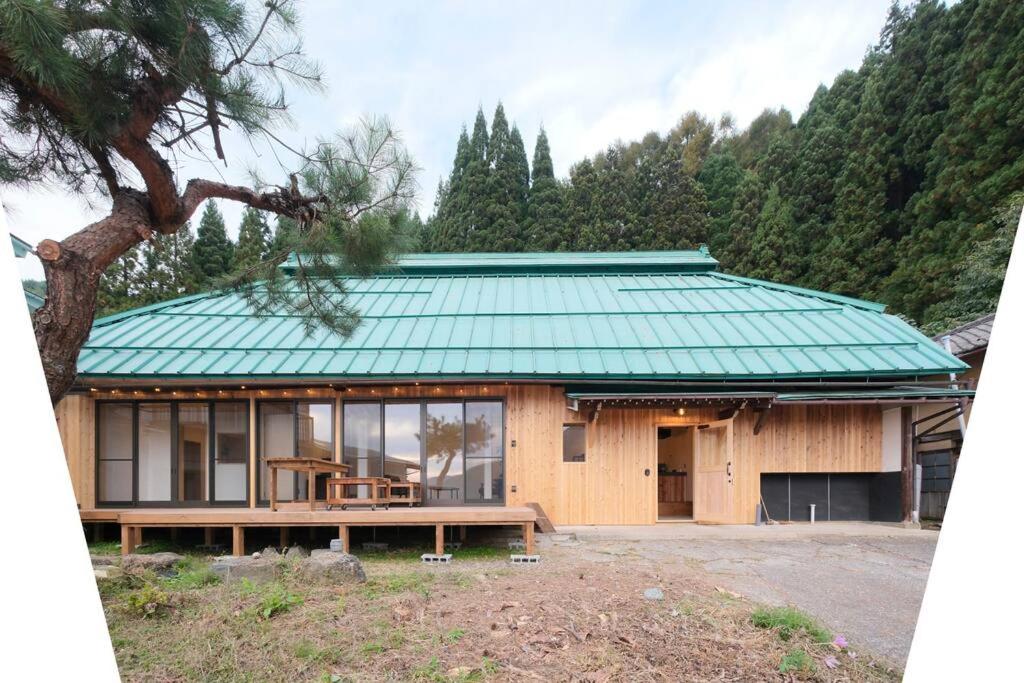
[80,504,538,555]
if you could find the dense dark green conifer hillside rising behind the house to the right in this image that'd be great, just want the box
[422,0,1024,330]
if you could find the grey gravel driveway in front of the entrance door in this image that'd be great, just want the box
[552,522,938,667]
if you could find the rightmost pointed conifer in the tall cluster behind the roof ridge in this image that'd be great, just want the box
[525,127,572,251]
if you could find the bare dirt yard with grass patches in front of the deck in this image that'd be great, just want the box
[92,537,899,683]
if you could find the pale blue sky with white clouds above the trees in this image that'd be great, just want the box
[0,0,889,278]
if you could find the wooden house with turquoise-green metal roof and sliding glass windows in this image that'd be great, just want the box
[57,248,973,552]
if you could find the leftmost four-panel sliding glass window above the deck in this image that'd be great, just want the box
[96,401,249,505]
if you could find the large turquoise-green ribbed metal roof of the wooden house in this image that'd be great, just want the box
[79,251,966,381]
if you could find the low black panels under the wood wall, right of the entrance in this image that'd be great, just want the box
[761,472,900,521]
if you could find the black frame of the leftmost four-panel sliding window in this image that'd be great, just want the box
[93,397,252,508]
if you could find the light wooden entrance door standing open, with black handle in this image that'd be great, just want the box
[693,420,735,523]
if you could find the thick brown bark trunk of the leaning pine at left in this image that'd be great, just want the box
[32,191,153,404]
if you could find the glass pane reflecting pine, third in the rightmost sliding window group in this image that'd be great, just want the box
[426,403,464,502]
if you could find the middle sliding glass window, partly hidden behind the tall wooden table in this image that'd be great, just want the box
[259,400,334,501]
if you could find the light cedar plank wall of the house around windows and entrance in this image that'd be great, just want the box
[55,384,882,524]
